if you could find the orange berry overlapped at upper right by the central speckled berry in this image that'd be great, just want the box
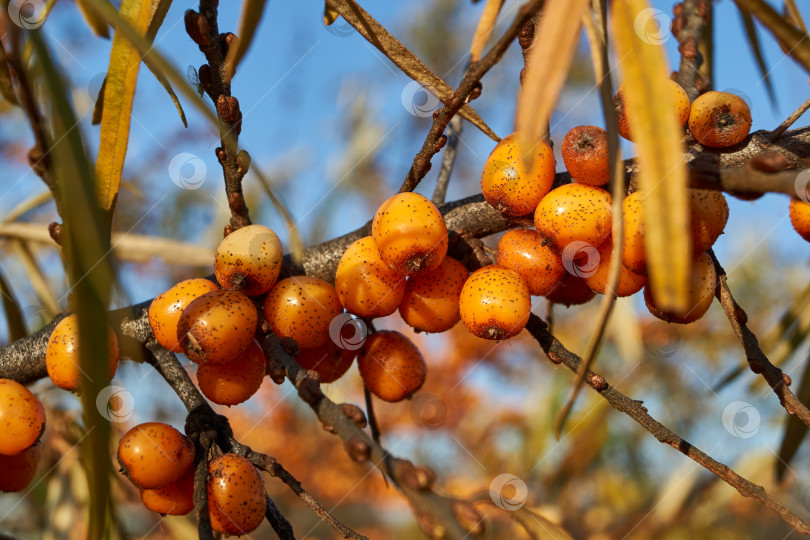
[335,236,405,318]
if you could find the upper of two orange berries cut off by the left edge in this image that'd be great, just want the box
[0,379,45,455]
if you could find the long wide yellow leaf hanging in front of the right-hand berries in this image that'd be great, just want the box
[611,0,692,312]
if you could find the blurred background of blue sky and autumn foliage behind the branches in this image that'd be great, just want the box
[0,0,810,539]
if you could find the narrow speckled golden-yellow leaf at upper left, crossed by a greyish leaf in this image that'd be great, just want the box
[96,0,152,211]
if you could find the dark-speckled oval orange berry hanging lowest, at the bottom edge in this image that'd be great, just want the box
[208,454,267,536]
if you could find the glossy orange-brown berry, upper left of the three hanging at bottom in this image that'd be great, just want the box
[118,422,195,489]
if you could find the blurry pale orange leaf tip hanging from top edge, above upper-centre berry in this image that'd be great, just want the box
[515,0,590,148]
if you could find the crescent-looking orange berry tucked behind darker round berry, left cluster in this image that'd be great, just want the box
[149,278,219,352]
